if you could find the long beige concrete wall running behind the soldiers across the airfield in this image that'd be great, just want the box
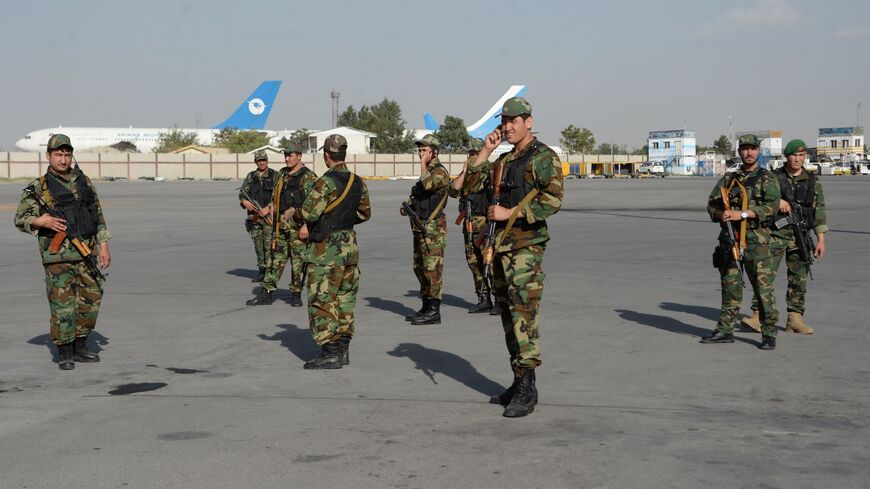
[0,152,646,180]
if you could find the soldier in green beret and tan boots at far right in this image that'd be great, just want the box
[743,139,828,334]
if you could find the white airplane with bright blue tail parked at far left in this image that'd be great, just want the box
[15,80,281,153]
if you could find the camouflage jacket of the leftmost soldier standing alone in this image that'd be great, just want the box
[15,169,112,264]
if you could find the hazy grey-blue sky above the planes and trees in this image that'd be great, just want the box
[0,0,870,150]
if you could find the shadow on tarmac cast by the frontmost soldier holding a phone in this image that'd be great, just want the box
[387,343,505,397]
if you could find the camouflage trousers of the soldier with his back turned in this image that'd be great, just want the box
[308,263,359,345]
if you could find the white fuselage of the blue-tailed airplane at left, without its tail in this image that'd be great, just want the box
[15,127,228,153]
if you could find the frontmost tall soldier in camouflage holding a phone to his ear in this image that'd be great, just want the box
[464,97,562,418]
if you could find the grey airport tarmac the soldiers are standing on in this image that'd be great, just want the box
[0,176,870,489]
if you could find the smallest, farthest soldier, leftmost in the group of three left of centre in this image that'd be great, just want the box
[239,150,278,282]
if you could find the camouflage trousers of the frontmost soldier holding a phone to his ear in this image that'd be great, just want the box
[492,244,546,372]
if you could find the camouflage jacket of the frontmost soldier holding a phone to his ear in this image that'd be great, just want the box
[463,137,563,253]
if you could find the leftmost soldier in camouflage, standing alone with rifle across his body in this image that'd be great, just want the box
[15,134,112,370]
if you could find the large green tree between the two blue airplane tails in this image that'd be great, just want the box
[338,98,414,153]
